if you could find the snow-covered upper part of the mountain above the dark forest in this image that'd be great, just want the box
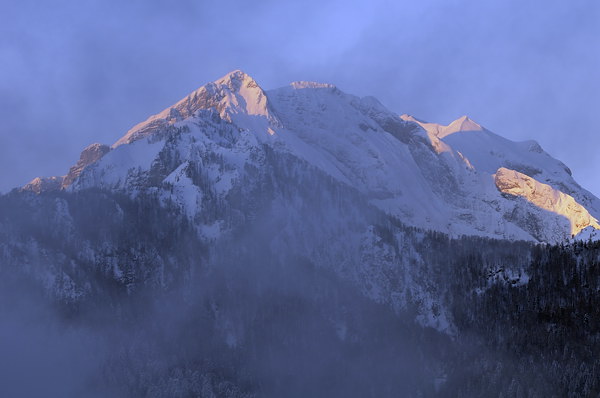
[25,71,600,242]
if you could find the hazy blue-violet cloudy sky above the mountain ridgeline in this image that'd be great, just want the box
[0,0,600,196]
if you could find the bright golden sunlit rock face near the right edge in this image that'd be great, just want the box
[494,167,600,235]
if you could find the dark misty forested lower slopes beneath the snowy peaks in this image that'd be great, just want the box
[0,149,600,397]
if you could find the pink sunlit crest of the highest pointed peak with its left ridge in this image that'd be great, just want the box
[113,70,279,148]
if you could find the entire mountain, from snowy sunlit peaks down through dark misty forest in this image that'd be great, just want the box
[0,71,600,398]
